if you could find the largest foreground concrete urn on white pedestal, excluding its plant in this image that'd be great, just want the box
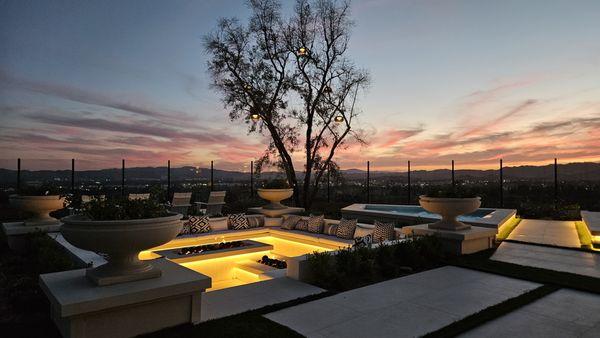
[60,213,183,286]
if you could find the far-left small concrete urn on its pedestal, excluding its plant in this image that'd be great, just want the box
[9,195,65,225]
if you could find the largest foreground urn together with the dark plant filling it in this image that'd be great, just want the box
[61,198,182,285]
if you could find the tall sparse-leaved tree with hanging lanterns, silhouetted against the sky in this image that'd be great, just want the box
[205,0,369,208]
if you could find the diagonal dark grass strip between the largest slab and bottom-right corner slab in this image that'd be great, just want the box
[423,285,560,338]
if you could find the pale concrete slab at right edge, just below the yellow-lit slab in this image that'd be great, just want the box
[491,242,600,278]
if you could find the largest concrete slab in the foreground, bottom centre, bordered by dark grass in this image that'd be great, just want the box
[265,266,540,337]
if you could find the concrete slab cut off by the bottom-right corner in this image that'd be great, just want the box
[462,289,600,337]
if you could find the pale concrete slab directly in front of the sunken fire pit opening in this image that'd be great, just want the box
[201,277,325,322]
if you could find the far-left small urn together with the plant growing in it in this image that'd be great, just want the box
[9,184,64,225]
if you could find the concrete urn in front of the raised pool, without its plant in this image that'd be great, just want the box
[419,195,481,230]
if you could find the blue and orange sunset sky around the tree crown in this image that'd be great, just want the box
[0,0,600,170]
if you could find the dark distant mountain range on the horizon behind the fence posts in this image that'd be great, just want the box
[0,162,600,185]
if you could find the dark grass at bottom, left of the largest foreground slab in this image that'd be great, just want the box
[140,291,335,338]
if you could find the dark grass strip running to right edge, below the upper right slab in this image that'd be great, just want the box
[448,249,600,294]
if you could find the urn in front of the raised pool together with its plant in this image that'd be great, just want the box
[419,186,481,230]
